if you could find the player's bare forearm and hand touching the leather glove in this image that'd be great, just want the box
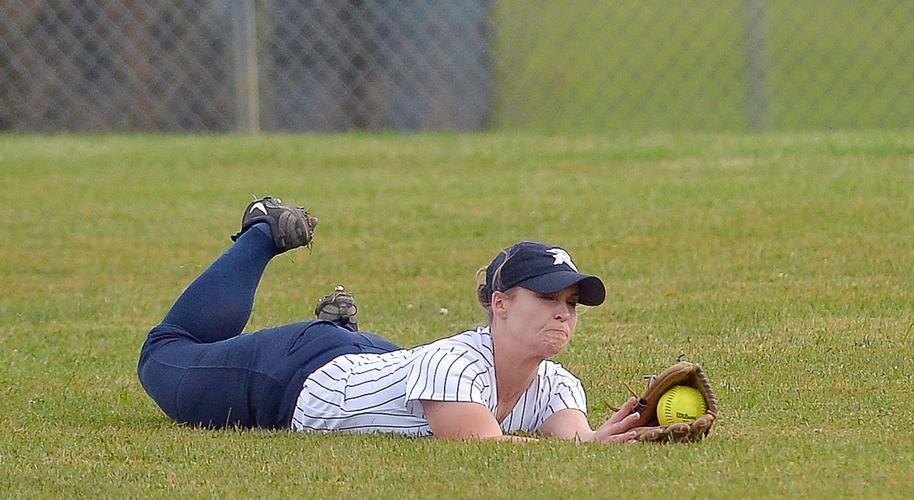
[539,398,638,443]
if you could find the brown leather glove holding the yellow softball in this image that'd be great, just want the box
[632,361,717,443]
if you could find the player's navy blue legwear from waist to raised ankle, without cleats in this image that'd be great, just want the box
[137,229,400,429]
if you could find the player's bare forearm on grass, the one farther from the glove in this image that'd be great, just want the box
[420,400,536,442]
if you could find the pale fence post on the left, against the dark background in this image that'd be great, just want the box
[231,0,260,134]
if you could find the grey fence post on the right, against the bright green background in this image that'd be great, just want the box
[745,0,771,130]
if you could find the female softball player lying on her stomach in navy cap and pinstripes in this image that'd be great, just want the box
[137,197,638,442]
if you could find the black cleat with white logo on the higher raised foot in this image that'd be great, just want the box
[232,196,317,253]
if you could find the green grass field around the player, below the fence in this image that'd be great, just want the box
[0,132,914,498]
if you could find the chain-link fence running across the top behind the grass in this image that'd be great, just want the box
[0,0,914,132]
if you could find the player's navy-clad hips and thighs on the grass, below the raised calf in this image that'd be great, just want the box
[139,320,399,429]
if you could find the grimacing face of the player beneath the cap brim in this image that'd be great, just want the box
[504,285,578,358]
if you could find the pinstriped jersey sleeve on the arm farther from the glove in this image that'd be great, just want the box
[406,348,489,405]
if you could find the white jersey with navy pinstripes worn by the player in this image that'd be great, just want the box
[292,327,587,436]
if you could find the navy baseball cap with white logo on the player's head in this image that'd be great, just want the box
[485,241,606,306]
